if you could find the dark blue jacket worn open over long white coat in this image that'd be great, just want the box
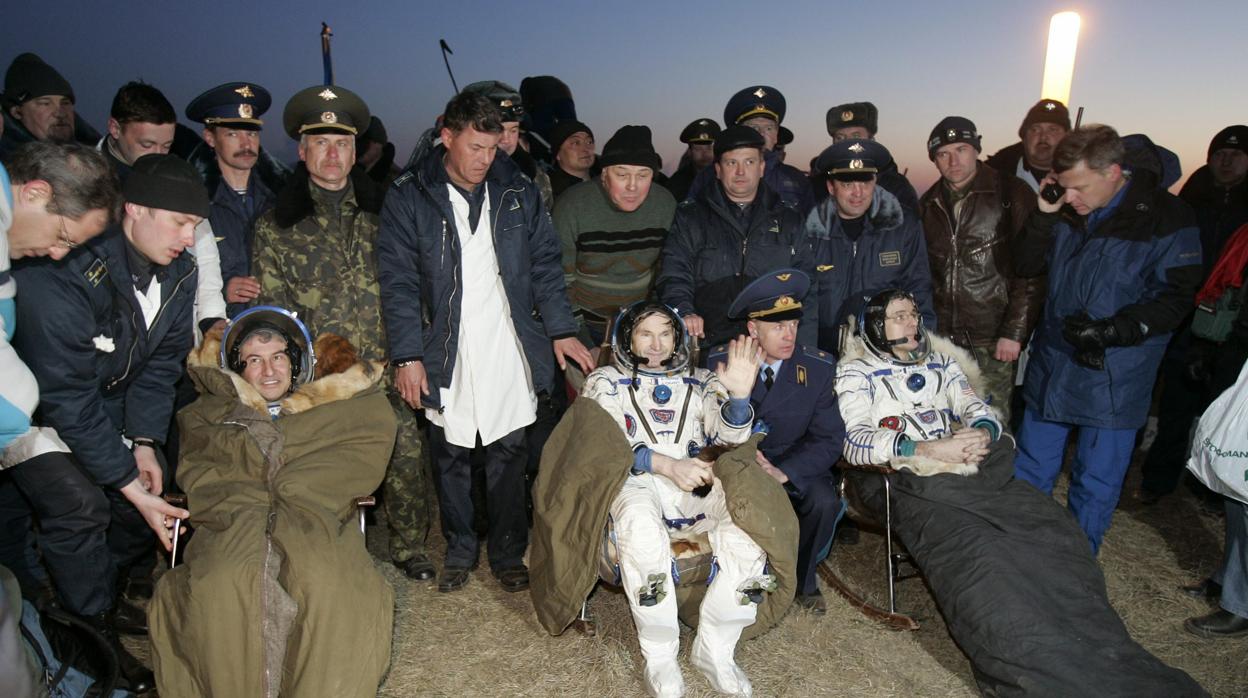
[377,145,577,410]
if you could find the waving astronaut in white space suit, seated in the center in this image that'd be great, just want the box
[582,302,771,697]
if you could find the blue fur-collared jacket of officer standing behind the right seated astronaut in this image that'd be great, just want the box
[806,186,936,353]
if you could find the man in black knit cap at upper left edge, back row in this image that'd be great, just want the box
[0,54,100,161]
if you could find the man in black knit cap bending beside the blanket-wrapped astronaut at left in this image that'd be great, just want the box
[11,155,208,692]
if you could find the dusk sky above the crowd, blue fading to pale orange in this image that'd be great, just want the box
[0,0,1248,194]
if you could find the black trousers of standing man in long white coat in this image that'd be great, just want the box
[429,425,529,569]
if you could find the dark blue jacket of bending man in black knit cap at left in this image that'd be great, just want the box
[14,227,197,488]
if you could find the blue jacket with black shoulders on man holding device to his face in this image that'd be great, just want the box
[1015,170,1201,430]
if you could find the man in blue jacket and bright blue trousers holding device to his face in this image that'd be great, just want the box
[1015,125,1201,553]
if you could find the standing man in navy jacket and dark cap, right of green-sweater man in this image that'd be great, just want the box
[658,125,819,347]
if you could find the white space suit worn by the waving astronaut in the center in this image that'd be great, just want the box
[582,303,770,696]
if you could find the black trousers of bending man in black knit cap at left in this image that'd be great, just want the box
[10,452,155,616]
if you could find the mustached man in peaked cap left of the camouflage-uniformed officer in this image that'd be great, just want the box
[186,82,285,317]
